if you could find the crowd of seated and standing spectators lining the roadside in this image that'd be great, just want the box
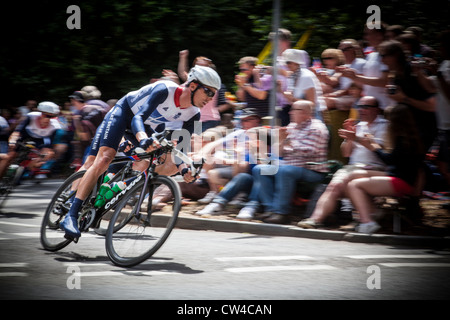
[0,24,450,233]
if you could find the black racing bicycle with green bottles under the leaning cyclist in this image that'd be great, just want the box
[41,133,203,267]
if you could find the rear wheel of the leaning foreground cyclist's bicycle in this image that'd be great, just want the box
[41,170,86,251]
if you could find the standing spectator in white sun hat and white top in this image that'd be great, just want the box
[283,49,326,119]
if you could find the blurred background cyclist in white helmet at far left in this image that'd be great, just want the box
[0,101,61,177]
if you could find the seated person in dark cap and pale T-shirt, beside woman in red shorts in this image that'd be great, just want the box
[298,96,387,229]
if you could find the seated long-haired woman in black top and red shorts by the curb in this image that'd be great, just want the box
[347,104,423,233]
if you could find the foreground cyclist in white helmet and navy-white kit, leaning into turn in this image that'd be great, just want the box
[60,66,221,239]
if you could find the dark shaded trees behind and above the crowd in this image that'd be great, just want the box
[0,0,450,108]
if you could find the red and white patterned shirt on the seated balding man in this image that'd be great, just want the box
[282,119,329,172]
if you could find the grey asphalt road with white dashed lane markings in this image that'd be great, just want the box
[0,180,450,302]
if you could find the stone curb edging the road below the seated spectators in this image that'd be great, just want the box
[176,216,450,248]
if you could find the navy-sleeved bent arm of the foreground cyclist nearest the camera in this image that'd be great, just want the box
[131,84,169,141]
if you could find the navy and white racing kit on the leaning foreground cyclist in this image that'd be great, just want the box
[90,81,200,155]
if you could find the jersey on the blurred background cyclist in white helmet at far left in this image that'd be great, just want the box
[16,111,61,149]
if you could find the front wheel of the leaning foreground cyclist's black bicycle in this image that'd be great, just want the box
[106,176,181,267]
